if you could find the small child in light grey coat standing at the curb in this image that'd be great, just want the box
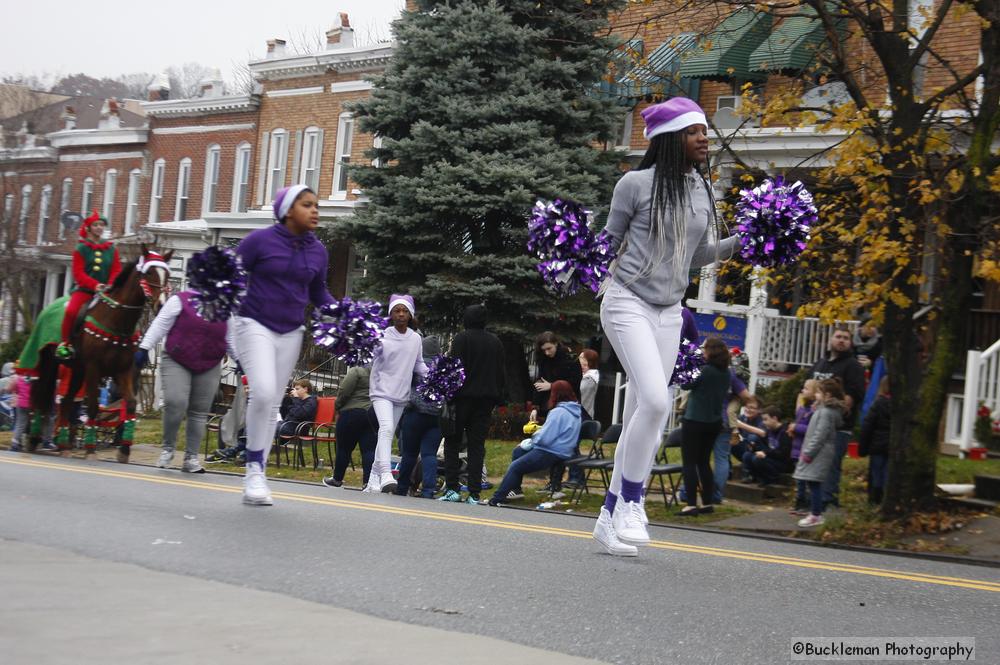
[795,379,847,527]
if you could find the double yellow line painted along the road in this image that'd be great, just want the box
[0,456,1000,592]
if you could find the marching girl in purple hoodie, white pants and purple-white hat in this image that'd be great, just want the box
[231,185,333,506]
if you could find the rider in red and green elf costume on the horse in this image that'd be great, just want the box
[56,210,122,360]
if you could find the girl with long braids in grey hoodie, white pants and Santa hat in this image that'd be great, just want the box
[594,97,736,556]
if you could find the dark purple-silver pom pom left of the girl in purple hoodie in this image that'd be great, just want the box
[187,245,247,322]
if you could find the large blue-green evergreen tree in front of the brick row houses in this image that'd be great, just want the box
[335,0,624,394]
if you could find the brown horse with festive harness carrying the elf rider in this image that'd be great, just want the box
[31,244,173,463]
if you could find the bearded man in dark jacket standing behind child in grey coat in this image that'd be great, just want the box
[809,325,865,507]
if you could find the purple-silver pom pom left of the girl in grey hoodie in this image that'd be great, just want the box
[528,199,615,296]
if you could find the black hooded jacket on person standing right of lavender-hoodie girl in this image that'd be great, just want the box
[450,305,507,404]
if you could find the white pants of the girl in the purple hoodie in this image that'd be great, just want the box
[233,316,302,461]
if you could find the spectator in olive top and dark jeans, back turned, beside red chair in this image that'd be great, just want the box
[323,367,377,487]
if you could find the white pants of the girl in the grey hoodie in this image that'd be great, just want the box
[601,283,682,494]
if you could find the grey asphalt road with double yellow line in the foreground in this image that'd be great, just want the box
[0,453,1000,665]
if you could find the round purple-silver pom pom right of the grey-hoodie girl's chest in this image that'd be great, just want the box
[736,176,819,268]
